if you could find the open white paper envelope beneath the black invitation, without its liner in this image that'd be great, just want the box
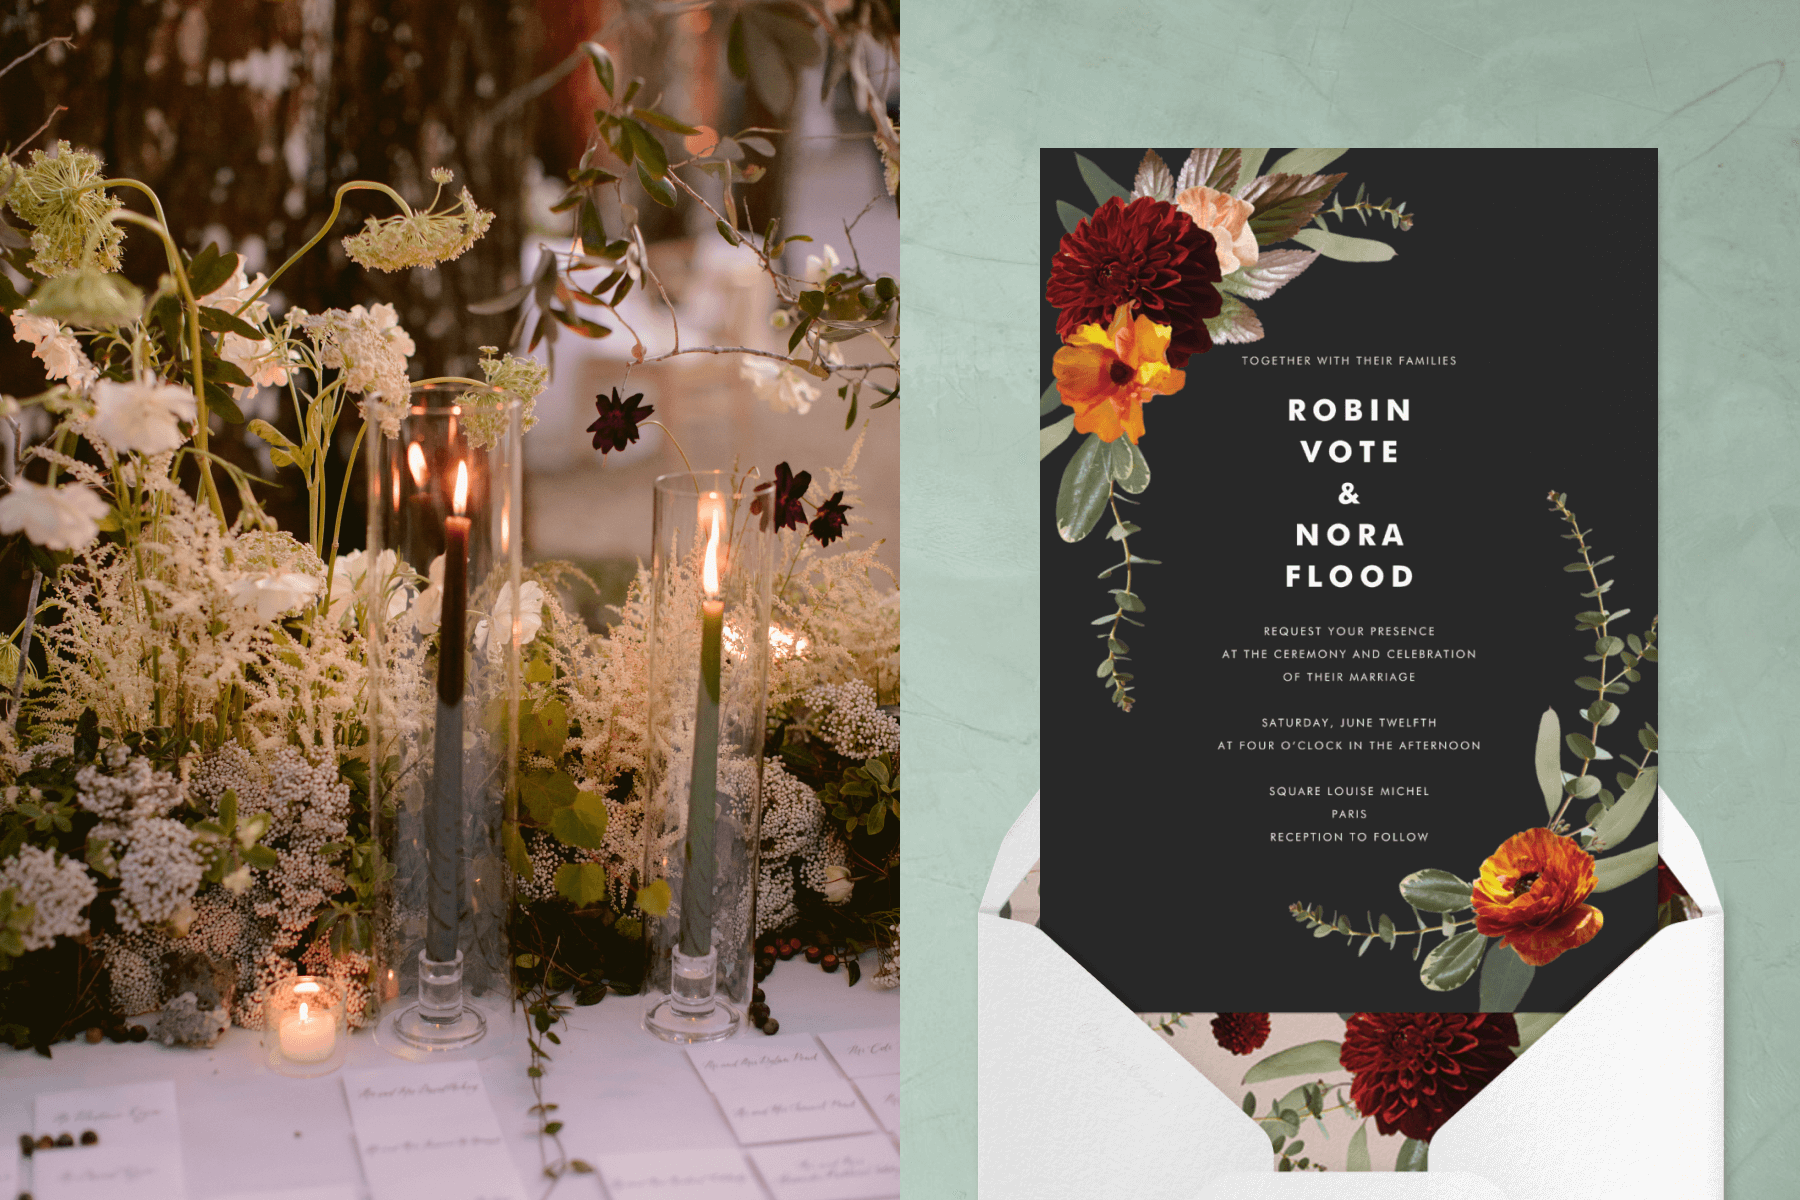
[977,792,1724,1200]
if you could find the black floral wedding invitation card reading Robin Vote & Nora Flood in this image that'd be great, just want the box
[1040,149,1658,1013]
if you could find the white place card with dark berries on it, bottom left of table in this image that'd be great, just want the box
[31,1081,187,1200]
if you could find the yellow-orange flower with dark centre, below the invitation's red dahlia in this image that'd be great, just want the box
[1051,304,1188,443]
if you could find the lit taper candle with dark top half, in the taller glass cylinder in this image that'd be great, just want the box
[425,462,470,963]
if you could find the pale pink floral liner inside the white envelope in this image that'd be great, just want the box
[1001,860,1699,1171]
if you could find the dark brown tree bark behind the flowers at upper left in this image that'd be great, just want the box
[0,0,540,545]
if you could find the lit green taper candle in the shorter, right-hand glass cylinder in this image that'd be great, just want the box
[680,491,725,957]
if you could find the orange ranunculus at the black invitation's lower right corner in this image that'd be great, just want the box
[1474,829,1602,966]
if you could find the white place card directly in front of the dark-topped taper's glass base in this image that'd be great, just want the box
[344,1061,526,1200]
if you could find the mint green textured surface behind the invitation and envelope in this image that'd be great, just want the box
[902,0,1800,1198]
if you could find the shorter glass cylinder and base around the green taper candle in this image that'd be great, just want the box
[641,471,774,1042]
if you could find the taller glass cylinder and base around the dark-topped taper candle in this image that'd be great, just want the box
[362,383,522,1058]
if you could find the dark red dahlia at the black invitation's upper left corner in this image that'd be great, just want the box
[1044,196,1220,369]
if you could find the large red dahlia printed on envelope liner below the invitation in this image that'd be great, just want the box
[1337,1013,1519,1142]
